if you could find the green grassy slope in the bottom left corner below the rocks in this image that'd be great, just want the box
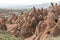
[0,31,21,40]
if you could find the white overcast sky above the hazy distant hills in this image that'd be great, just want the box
[0,0,60,5]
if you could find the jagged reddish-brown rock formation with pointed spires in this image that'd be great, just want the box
[0,2,60,40]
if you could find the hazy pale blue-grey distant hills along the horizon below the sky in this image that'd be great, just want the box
[0,2,60,9]
